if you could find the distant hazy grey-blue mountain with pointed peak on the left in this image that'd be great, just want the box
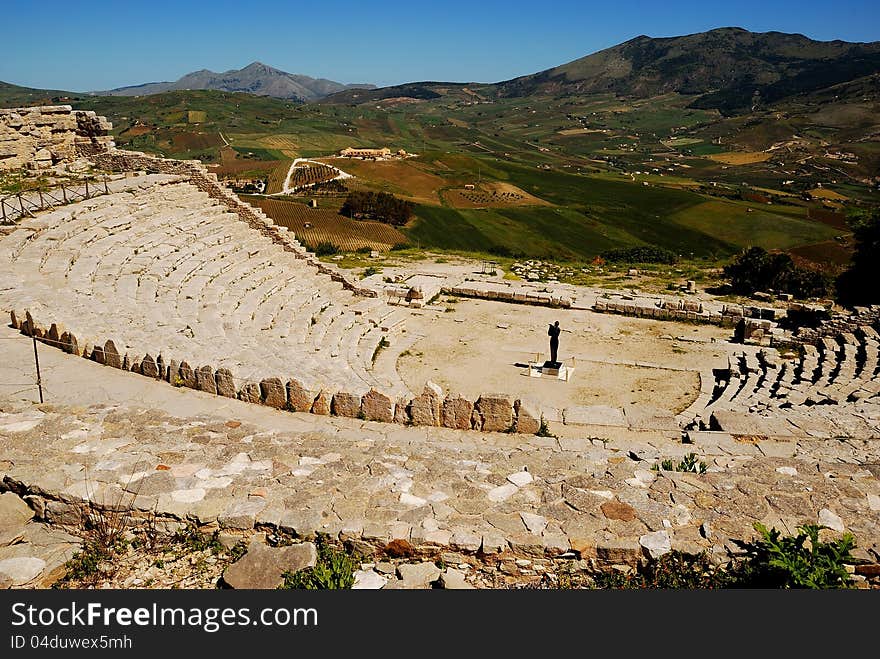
[94,62,373,101]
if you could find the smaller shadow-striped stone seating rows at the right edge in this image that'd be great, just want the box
[698,325,880,437]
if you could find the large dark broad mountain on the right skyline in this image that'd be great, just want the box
[496,28,880,114]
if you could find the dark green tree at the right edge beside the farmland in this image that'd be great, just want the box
[836,209,880,306]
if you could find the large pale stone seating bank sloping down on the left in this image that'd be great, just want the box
[0,175,409,396]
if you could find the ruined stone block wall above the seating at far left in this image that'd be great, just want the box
[0,105,113,171]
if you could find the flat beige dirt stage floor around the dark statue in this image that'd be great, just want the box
[397,296,732,413]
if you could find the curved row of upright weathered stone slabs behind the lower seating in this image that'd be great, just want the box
[10,311,543,434]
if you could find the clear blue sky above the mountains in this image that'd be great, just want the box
[0,0,880,91]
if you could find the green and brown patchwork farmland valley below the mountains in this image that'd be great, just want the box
[0,81,877,264]
